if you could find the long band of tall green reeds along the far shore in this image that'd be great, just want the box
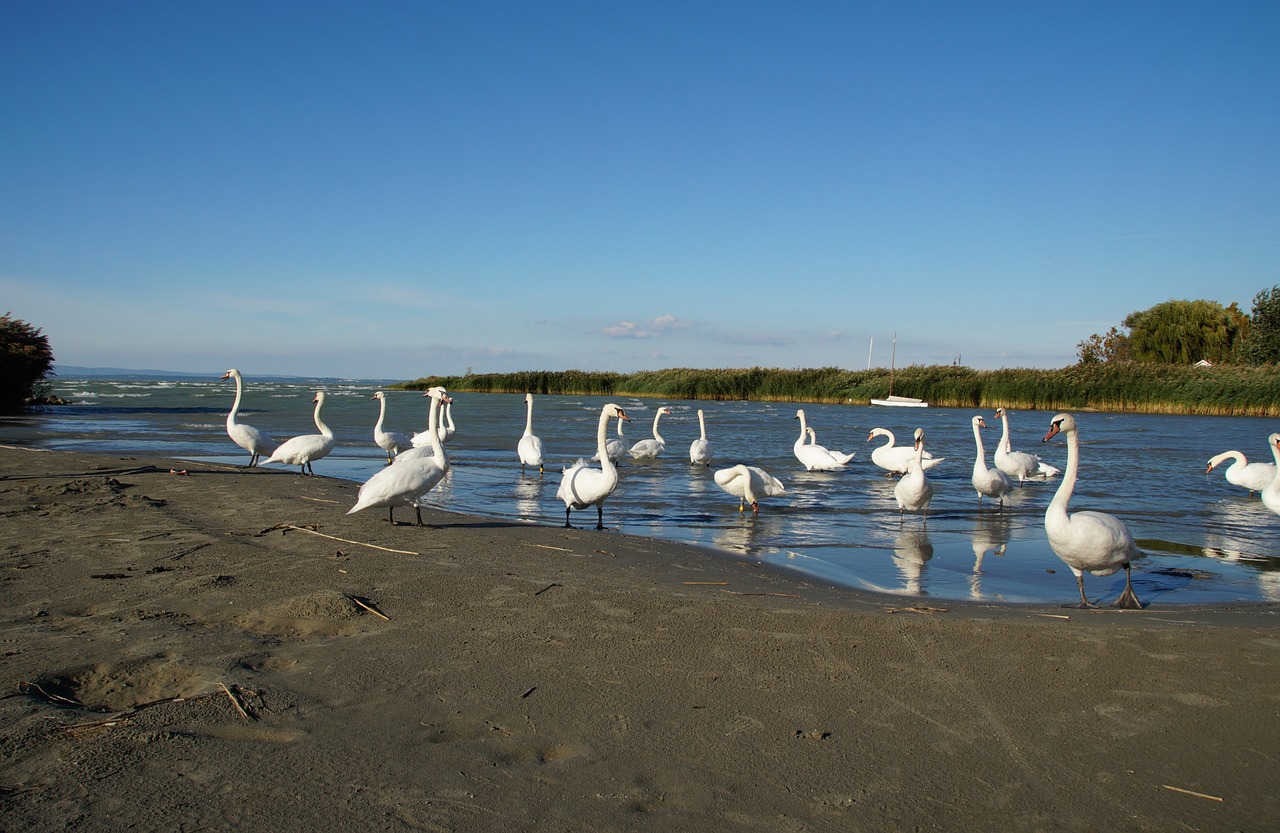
[397,363,1280,416]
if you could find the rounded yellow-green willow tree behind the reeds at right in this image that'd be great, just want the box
[1124,301,1245,365]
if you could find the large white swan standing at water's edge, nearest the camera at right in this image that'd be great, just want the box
[1044,413,1143,610]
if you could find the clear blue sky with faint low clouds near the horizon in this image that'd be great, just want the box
[0,0,1280,377]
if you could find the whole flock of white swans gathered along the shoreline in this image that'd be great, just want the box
[223,369,1280,609]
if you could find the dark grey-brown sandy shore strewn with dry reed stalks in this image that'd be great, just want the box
[0,449,1280,833]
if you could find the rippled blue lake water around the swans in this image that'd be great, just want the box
[0,377,1280,609]
